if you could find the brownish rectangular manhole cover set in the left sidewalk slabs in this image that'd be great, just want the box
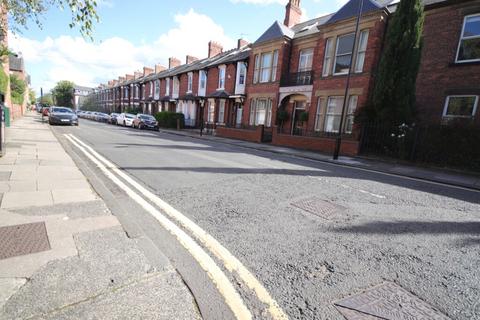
[0,222,50,260]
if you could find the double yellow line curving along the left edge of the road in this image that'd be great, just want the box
[64,134,288,320]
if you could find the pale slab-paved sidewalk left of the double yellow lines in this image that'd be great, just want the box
[0,114,200,319]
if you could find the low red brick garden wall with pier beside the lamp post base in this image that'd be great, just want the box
[272,128,359,156]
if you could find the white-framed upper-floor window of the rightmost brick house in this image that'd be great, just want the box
[457,14,480,62]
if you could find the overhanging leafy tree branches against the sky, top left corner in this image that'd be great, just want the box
[0,0,99,38]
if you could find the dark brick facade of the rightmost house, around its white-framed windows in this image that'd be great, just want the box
[417,1,480,125]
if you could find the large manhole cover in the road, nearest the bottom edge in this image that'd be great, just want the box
[335,282,450,320]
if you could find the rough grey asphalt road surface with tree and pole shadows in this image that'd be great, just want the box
[54,120,480,320]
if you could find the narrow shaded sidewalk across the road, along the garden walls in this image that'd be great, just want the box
[160,129,480,190]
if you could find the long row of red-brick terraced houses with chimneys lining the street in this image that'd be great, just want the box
[87,0,480,155]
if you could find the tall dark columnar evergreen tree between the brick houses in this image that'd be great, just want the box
[373,0,424,125]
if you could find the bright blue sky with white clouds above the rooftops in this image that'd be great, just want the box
[9,0,347,94]
